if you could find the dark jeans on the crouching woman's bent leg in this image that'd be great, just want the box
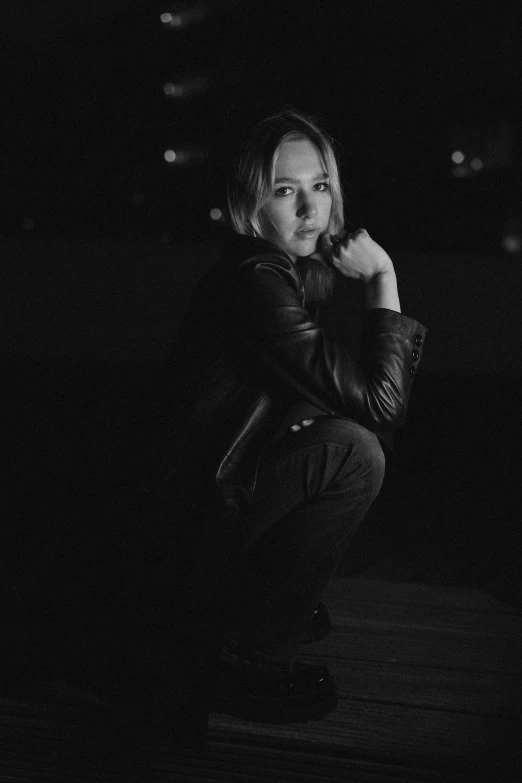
[224,418,385,666]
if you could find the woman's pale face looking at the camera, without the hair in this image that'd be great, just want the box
[260,139,332,261]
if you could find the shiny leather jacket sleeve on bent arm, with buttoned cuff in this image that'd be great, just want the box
[228,256,427,432]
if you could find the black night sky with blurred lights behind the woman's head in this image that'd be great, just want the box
[1,0,521,250]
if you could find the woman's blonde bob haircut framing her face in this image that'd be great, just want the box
[227,109,344,237]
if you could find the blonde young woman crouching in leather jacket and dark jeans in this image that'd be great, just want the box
[171,111,426,723]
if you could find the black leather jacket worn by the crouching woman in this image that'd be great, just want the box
[172,228,426,519]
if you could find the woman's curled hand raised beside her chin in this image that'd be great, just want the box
[320,228,394,283]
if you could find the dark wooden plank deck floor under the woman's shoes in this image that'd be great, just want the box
[0,579,522,783]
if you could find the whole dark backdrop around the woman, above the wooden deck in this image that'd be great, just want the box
[0,0,522,632]
